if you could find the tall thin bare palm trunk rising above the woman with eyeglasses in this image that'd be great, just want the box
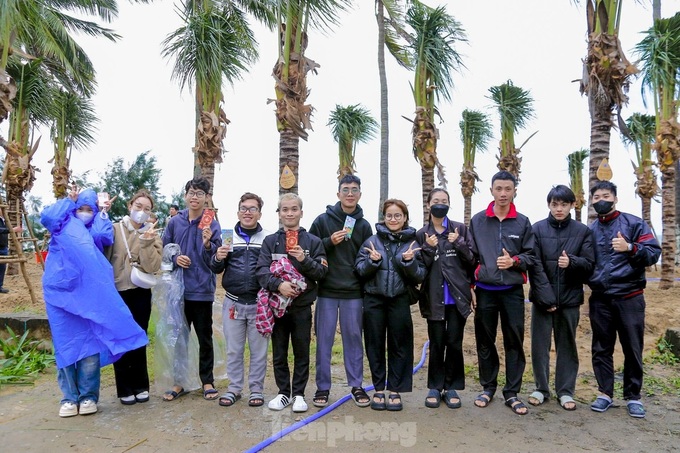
[376,0,390,221]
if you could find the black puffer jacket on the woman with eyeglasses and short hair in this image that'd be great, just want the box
[355,223,426,297]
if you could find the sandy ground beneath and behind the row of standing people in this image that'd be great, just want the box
[0,265,680,453]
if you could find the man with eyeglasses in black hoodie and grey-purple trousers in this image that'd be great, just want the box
[309,175,373,407]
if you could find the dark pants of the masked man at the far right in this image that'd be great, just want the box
[589,293,645,400]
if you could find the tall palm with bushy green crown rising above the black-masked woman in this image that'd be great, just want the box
[406,0,467,222]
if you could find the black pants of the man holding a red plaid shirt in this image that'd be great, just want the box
[272,305,312,396]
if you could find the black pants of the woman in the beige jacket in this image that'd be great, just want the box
[113,288,151,398]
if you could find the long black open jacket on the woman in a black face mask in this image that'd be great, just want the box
[416,219,477,321]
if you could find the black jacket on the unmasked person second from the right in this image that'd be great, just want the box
[529,214,595,308]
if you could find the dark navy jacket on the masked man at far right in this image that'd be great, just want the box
[588,211,661,297]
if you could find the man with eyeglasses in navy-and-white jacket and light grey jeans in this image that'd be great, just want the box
[210,192,270,407]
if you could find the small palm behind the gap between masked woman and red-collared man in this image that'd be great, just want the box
[458,109,493,225]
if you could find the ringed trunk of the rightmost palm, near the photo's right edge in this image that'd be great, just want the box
[659,165,676,289]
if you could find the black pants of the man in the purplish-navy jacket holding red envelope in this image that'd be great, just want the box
[184,299,215,385]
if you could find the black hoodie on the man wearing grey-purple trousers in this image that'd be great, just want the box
[309,202,373,299]
